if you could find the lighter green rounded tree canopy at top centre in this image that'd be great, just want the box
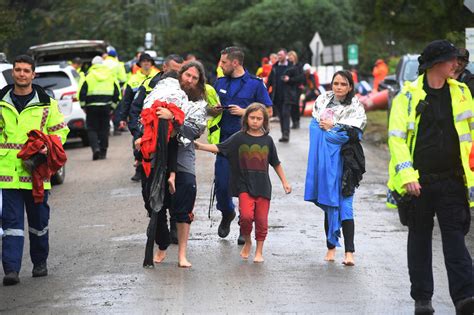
[163,0,362,69]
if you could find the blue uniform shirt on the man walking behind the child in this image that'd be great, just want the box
[214,71,272,141]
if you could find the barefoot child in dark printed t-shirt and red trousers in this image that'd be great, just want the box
[194,103,291,263]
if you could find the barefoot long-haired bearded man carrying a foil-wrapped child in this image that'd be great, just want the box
[135,61,207,268]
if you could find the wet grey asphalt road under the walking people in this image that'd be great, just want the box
[0,118,474,314]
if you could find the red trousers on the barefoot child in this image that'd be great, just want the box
[239,192,270,241]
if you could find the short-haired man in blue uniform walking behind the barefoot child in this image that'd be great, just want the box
[209,47,272,245]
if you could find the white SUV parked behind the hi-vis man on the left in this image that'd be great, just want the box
[33,63,89,146]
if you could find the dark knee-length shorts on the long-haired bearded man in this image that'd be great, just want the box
[171,172,196,223]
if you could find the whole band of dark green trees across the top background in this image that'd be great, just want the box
[0,0,474,75]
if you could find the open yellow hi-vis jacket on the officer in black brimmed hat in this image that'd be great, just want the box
[387,75,474,207]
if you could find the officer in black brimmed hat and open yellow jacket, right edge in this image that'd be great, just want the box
[388,40,474,315]
